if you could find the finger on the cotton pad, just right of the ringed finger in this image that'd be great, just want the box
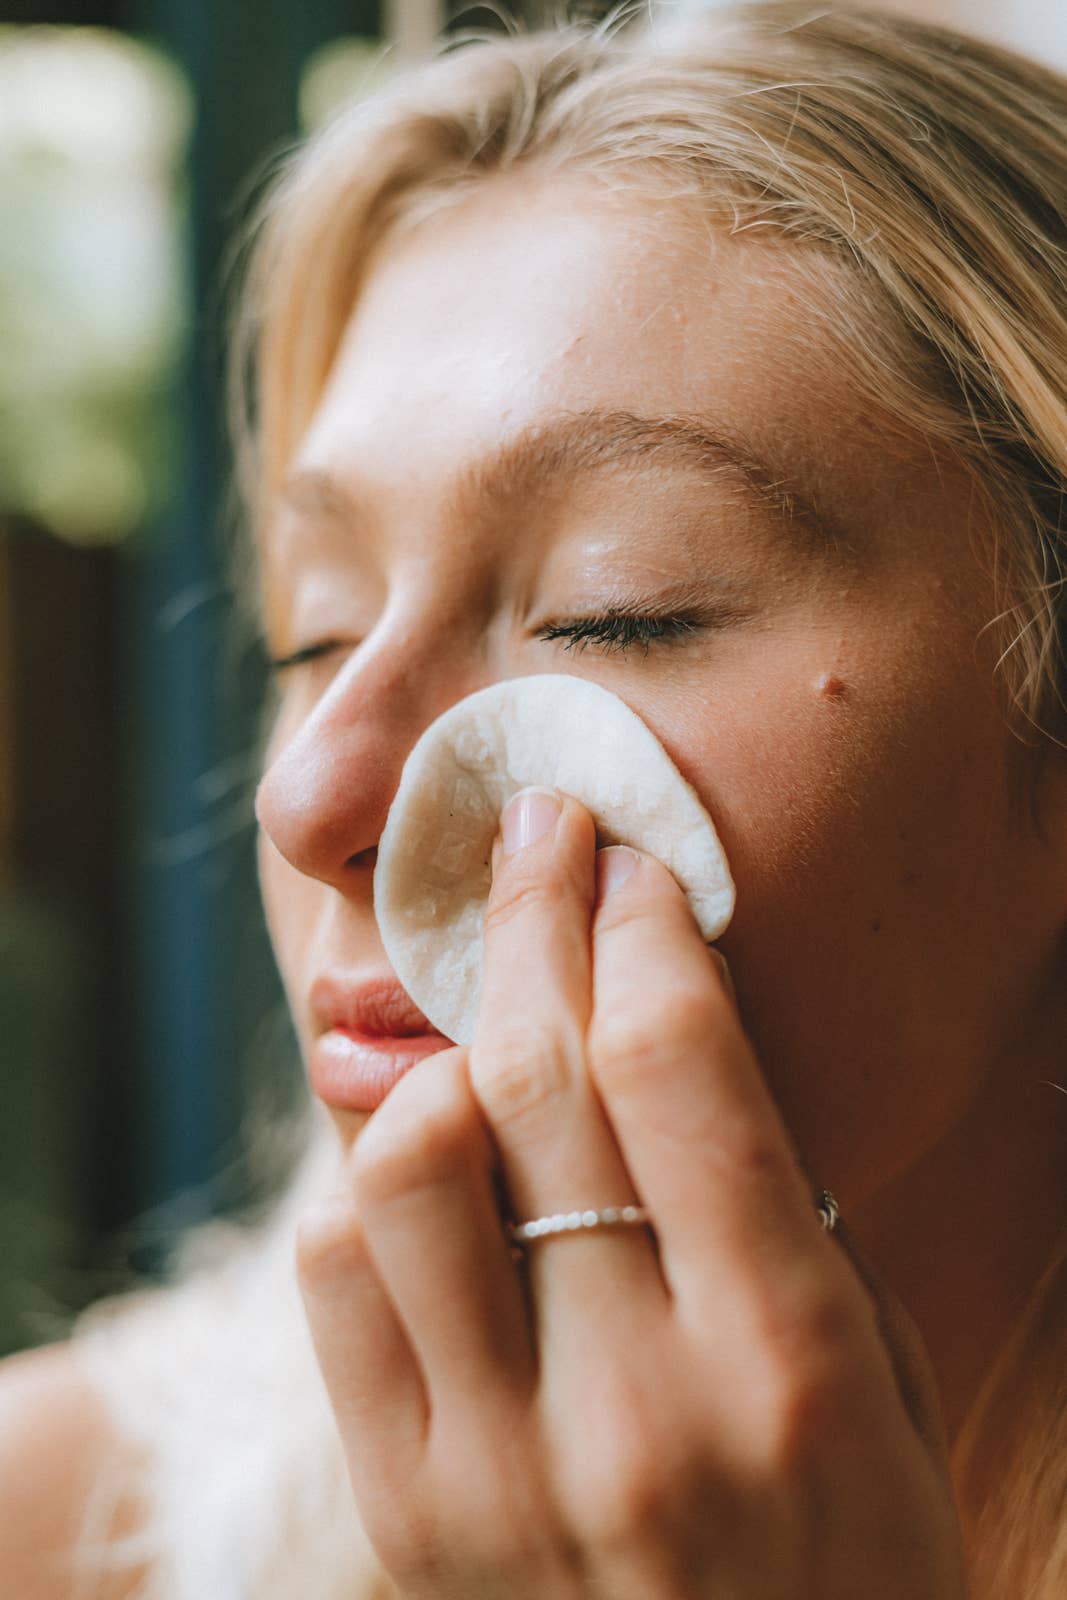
[589,848,824,1309]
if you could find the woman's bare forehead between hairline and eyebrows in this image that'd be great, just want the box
[293,174,940,544]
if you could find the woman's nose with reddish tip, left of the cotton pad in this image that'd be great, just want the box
[256,643,480,893]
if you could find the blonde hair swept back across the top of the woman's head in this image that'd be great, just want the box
[234,3,1067,736]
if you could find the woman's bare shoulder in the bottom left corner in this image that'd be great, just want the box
[0,1344,150,1600]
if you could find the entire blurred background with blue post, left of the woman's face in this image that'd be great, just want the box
[0,0,404,1354]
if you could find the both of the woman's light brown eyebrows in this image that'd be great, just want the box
[280,408,825,531]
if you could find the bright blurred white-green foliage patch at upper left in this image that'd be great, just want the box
[0,27,192,542]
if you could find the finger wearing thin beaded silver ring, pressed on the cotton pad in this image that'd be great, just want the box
[470,790,665,1336]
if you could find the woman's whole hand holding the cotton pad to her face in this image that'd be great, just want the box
[298,797,965,1600]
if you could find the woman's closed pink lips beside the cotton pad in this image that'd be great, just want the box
[309,976,453,1112]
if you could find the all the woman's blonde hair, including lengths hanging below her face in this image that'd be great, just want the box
[77,3,1067,1600]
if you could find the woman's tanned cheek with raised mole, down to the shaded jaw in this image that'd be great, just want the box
[664,643,1008,1198]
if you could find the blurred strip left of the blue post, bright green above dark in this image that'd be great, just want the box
[0,26,192,1350]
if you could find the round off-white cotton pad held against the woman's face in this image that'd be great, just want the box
[374,674,734,1045]
